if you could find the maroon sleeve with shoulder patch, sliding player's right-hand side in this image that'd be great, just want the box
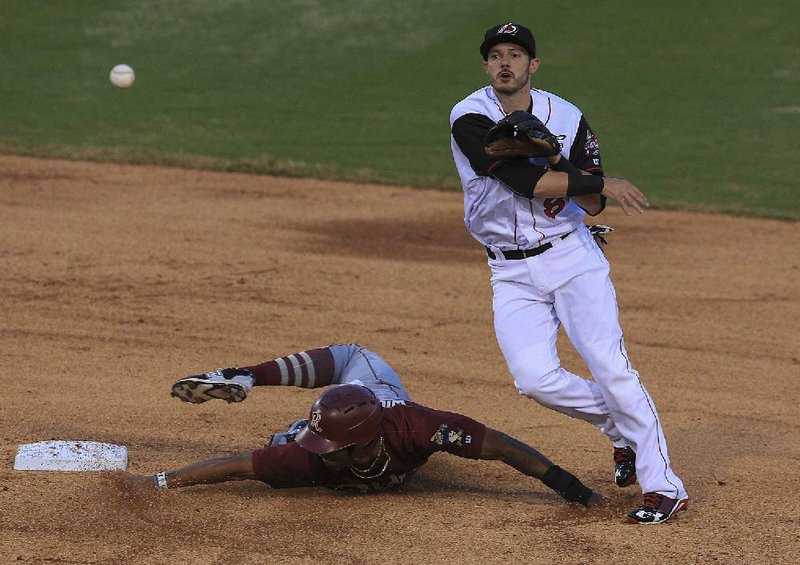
[408,405,486,459]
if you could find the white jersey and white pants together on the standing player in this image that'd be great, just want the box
[450,86,686,500]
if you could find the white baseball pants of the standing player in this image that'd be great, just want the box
[489,227,686,498]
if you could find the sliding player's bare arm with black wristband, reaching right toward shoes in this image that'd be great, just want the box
[480,427,602,507]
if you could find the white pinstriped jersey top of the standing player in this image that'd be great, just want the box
[450,86,602,250]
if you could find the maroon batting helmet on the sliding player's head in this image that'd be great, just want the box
[295,384,383,455]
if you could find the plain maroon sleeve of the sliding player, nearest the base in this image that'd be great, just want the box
[252,442,325,488]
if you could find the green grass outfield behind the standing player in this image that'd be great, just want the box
[0,0,800,219]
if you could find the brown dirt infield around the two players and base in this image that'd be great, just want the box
[0,156,800,564]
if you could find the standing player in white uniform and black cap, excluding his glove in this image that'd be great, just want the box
[450,23,688,524]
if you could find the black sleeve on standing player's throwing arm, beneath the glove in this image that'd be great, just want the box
[451,114,547,198]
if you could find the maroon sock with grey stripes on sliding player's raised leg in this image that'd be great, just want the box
[243,347,334,388]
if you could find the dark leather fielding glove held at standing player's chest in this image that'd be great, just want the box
[483,110,561,159]
